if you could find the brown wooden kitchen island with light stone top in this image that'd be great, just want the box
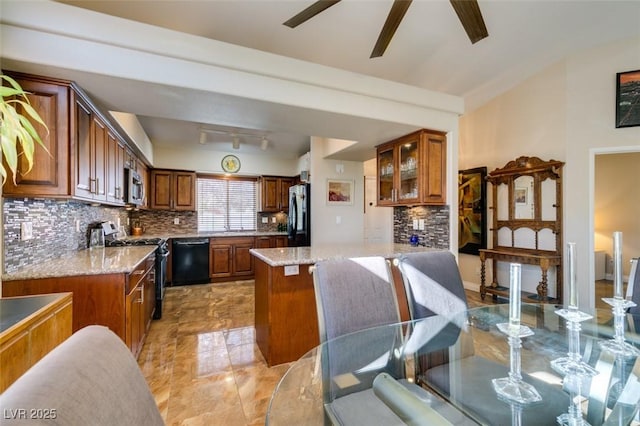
[251,244,444,366]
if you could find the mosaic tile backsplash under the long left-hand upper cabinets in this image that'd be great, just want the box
[3,198,128,272]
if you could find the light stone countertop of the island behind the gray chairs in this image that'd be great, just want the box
[250,243,438,266]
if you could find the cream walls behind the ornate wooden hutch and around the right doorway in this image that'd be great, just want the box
[458,38,640,307]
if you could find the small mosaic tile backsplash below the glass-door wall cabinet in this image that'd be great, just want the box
[393,206,449,250]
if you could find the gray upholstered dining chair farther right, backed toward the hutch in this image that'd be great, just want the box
[395,251,569,424]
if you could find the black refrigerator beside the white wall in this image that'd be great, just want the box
[287,183,311,247]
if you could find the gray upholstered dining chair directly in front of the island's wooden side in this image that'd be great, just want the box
[311,257,472,425]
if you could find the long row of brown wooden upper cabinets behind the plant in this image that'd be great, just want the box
[3,72,144,206]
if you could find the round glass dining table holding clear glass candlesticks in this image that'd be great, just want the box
[266,304,640,426]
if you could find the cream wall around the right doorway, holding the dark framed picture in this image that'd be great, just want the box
[564,38,640,306]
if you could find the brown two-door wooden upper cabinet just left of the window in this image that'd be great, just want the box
[150,169,196,211]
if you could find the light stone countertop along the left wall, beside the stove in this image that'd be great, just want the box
[2,246,157,281]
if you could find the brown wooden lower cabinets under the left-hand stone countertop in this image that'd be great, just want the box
[2,254,155,357]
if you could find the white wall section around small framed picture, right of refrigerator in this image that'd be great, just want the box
[310,137,364,246]
